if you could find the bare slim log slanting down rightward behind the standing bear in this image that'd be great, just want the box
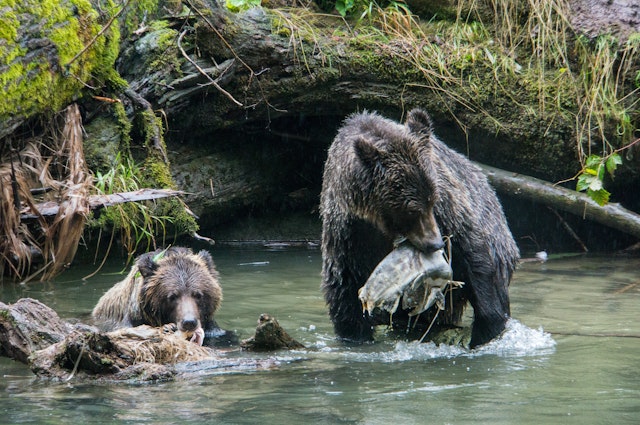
[476,163,640,239]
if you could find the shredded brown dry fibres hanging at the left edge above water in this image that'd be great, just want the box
[0,104,92,279]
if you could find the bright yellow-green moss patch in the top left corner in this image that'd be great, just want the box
[0,0,119,120]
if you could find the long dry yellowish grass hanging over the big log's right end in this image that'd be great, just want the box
[360,0,640,166]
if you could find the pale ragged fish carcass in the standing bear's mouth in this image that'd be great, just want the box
[358,242,464,316]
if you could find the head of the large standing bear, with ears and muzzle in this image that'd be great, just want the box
[354,109,444,253]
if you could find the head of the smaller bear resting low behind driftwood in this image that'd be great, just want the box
[136,247,222,332]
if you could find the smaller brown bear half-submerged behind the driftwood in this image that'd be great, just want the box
[92,247,225,344]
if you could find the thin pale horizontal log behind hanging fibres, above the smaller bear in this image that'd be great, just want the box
[20,189,184,220]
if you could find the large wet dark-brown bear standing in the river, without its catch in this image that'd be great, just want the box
[321,109,520,348]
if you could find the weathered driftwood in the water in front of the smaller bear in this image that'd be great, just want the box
[0,298,303,382]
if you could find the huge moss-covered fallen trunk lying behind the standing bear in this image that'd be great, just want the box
[118,0,638,180]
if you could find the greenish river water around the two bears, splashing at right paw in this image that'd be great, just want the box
[0,248,640,425]
